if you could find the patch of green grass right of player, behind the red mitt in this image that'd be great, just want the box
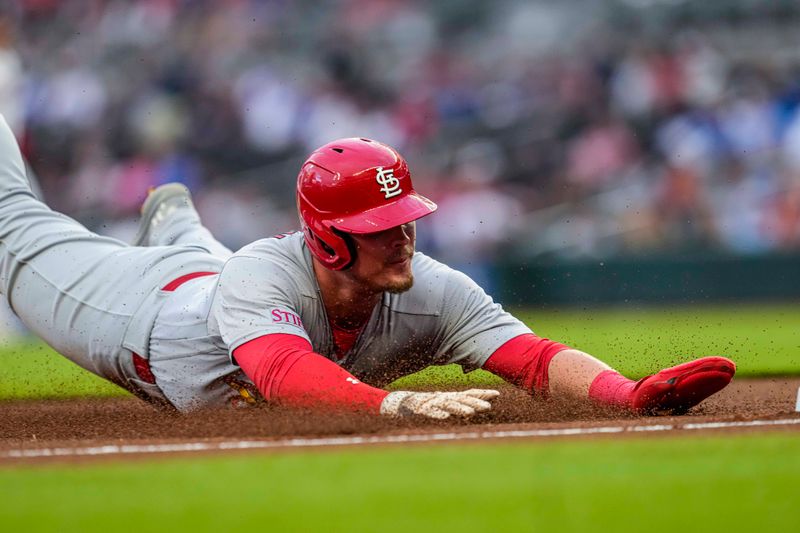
[518,303,800,376]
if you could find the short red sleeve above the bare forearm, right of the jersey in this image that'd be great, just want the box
[483,333,569,396]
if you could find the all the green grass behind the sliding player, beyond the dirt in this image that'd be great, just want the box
[0,304,800,400]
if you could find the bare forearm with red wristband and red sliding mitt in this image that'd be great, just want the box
[548,350,736,414]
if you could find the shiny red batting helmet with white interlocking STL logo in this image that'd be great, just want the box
[297,138,436,270]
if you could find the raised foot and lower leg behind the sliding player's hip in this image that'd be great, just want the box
[133,183,233,259]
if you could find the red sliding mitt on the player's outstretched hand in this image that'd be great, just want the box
[631,357,736,415]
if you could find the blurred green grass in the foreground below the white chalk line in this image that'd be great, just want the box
[0,433,800,533]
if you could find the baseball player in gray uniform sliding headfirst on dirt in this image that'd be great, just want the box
[0,114,735,418]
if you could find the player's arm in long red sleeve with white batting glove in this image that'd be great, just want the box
[234,334,499,419]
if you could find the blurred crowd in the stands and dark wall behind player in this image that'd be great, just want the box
[0,0,800,304]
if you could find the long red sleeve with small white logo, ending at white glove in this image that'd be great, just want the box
[233,333,388,413]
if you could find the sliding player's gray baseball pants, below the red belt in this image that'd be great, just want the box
[0,117,223,401]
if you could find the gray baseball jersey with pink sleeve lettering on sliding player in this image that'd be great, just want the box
[150,232,530,409]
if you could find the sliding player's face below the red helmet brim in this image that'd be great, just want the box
[349,222,417,293]
